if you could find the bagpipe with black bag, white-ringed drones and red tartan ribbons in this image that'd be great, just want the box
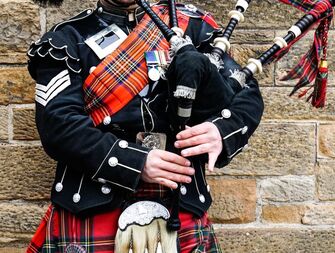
[115,0,335,252]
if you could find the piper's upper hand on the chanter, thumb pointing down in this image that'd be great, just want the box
[175,122,222,171]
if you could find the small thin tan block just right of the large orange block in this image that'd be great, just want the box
[262,205,306,224]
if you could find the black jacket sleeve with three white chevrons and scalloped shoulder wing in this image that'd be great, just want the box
[28,32,148,191]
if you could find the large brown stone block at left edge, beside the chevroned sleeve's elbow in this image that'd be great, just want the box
[0,145,55,200]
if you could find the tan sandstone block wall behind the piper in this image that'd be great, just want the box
[0,0,335,253]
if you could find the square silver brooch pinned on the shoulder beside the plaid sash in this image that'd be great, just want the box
[85,24,127,59]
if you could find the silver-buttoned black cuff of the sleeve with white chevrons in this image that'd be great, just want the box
[92,140,149,192]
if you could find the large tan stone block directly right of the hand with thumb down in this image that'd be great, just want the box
[215,122,316,176]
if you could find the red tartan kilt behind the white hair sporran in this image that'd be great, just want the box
[26,205,221,253]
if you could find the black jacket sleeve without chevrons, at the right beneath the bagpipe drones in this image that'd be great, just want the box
[208,54,264,168]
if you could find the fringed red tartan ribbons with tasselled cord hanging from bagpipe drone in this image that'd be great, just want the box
[274,0,333,107]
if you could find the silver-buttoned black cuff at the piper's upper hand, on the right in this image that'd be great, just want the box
[207,109,249,168]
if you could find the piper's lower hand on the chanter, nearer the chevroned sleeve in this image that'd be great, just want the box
[141,149,194,189]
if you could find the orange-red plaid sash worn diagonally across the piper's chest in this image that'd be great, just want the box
[83,6,189,125]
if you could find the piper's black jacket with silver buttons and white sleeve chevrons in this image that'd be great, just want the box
[28,0,263,216]
